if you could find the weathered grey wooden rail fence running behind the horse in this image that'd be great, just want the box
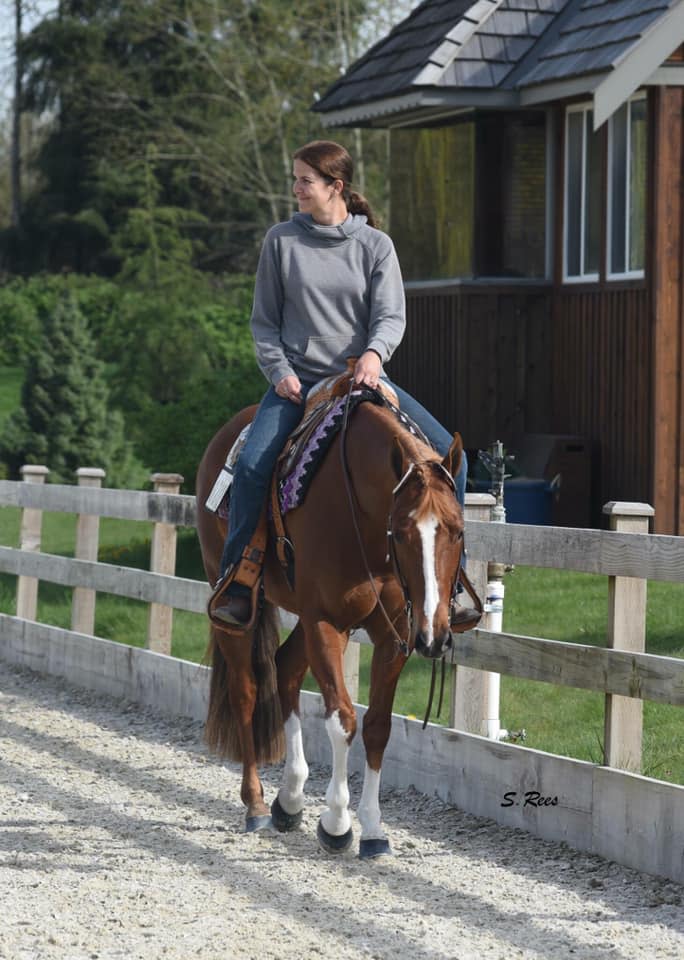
[0,467,684,882]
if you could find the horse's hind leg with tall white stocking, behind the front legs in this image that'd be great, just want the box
[271,623,309,833]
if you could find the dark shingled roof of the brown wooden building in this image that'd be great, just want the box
[313,0,684,126]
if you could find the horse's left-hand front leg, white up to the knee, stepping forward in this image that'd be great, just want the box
[305,621,356,853]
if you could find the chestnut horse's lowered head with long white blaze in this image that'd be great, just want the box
[388,434,463,658]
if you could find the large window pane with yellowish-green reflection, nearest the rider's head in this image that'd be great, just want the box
[390,122,474,280]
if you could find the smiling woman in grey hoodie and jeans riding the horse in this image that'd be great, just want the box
[213,140,479,626]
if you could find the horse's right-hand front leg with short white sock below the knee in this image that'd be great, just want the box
[357,597,408,859]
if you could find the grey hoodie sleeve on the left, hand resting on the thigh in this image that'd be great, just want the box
[251,230,294,386]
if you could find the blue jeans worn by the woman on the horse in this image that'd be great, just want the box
[221,379,468,576]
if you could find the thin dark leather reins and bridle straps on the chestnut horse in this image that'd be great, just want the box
[340,377,471,730]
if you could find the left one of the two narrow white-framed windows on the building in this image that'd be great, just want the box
[563,106,601,281]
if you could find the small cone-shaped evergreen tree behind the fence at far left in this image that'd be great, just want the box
[0,295,145,486]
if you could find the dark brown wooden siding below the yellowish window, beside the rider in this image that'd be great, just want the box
[388,285,551,449]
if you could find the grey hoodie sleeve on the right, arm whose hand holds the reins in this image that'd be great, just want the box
[366,235,406,363]
